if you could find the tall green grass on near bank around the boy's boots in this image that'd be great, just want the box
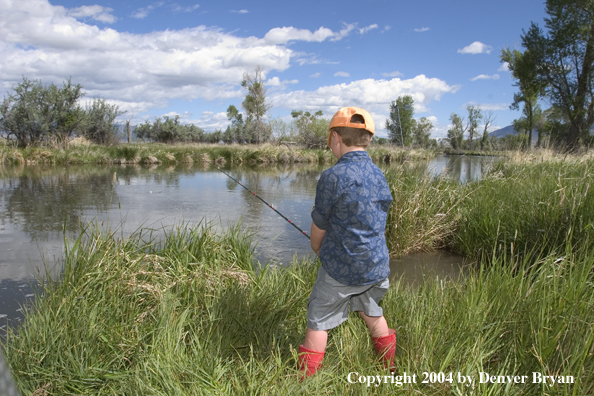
[3,221,594,396]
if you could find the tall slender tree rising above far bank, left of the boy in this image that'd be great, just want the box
[241,66,272,144]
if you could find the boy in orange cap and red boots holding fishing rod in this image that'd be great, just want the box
[299,107,396,376]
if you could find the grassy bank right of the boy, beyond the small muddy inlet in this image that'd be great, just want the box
[386,155,594,259]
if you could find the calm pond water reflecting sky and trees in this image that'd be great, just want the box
[0,156,494,328]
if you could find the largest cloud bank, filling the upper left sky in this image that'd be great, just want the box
[0,0,316,113]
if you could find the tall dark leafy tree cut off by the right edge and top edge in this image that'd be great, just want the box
[522,0,594,150]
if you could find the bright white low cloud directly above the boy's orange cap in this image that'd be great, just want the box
[272,74,460,116]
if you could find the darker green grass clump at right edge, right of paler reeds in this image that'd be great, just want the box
[450,160,594,257]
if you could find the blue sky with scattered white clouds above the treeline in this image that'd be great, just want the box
[0,0,546,137]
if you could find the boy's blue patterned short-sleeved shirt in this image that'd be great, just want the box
[311,151,392,286]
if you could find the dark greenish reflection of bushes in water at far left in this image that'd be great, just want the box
[0,168,119,239]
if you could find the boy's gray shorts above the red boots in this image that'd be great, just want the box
[307,267,390,330]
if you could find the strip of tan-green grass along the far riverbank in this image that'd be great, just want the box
[0,143,435,165]
